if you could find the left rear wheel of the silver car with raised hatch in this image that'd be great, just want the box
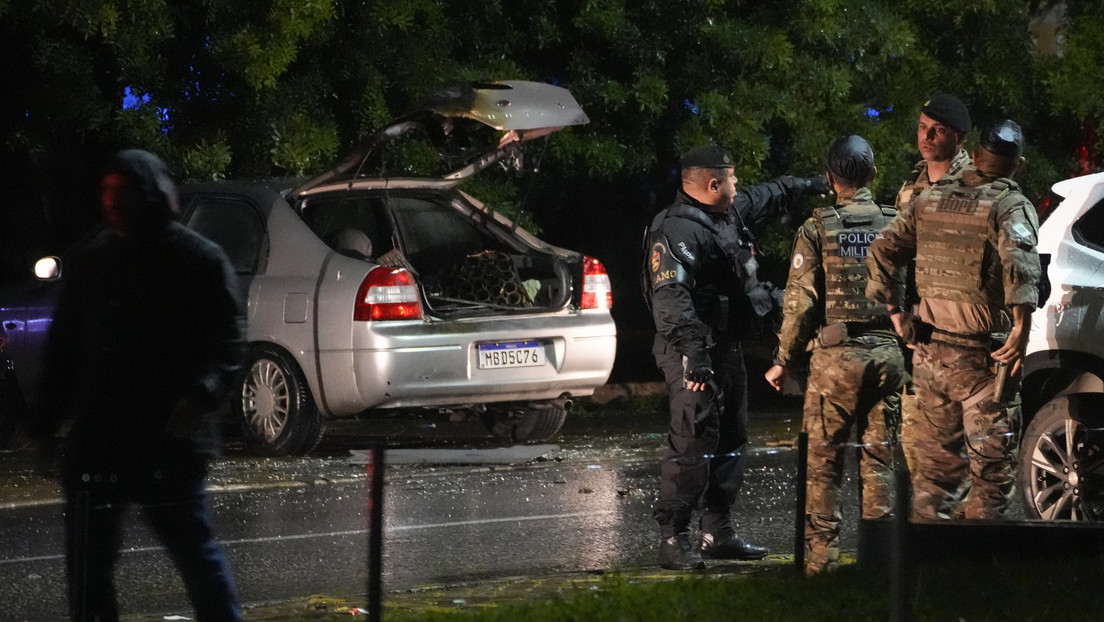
[234,347,325,455]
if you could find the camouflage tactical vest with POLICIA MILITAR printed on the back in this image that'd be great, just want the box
[820,202,896,324]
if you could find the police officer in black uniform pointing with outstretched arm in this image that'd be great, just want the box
[644,146,828,570]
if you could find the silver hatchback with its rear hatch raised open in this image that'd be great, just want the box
[0,82,616,455]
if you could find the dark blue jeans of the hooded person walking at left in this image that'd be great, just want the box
[63,450,242,622]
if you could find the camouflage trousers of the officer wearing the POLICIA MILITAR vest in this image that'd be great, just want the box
[803,336,907,574]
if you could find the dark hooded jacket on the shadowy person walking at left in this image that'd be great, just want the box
[33,150,244,458]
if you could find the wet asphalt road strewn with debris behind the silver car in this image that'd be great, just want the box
[0,397,857,620]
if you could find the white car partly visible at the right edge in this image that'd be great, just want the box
[1019,172,1104,520]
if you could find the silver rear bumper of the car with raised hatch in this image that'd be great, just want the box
[320,312,617,415]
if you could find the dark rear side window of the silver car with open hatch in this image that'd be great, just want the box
[184,197,265,274]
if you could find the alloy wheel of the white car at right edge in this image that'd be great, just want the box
[1019,393,1104,520]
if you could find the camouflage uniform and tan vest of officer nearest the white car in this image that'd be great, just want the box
[867,166,1040,519]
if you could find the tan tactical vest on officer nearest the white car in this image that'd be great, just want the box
[915,179,1018,305]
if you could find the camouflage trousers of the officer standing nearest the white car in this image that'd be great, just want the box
[901,341,1020,520]
